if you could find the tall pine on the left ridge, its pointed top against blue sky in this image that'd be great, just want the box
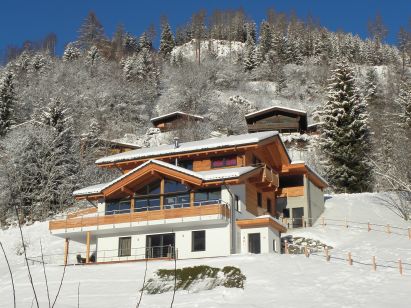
[78,12,106,50]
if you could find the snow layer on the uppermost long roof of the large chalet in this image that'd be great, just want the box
[96,131,278,164]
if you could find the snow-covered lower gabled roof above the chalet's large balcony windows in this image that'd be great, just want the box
[73,159,260,196]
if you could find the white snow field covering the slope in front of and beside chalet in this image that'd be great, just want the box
[0,194,411,308]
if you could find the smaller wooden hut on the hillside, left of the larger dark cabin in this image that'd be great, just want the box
[150,111,204,132]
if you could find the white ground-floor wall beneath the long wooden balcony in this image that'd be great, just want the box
[97,224,230,262]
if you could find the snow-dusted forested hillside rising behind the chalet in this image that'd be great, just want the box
[0,10,411,223]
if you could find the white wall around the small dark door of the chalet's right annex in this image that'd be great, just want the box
[241,227,281,253]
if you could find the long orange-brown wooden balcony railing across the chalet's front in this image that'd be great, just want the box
[49,200,230,231]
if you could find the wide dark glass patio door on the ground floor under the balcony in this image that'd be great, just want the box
[146,233,175,258]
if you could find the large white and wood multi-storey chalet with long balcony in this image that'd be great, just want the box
[49,131,327,262]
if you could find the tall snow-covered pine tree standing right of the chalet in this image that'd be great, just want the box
[320,61,373,193]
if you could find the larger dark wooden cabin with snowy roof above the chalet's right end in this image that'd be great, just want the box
[245,106,307,133]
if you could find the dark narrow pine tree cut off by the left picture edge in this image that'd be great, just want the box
[0,72,16,137]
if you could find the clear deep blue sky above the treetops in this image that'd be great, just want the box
[0,0,411,53]
